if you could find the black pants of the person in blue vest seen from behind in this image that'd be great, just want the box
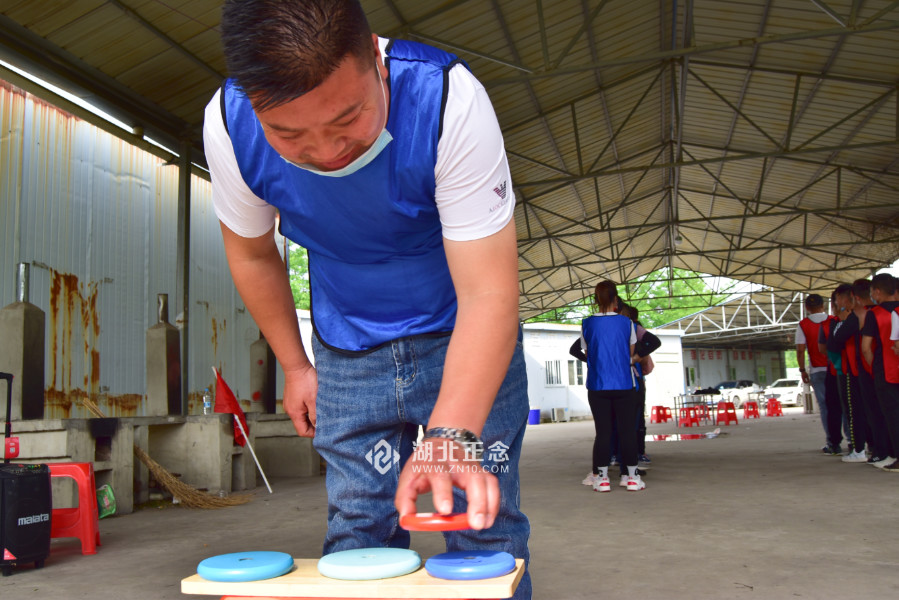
[587,390,640,473]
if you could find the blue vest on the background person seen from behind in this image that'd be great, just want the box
[582,315,637,391]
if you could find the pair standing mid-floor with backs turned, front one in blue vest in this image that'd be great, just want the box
[570,279,661,492]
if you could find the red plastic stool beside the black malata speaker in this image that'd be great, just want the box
[47,463,100,554]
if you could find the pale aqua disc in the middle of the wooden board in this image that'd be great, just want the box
[318,548,421,581]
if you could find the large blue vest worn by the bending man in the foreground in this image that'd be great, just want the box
[222,40,467,352]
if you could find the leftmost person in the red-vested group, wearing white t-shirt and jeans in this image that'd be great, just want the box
[796,294,843,454]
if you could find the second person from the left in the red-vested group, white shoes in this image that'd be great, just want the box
[827,283,868,463]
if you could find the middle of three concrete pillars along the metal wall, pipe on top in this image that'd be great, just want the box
[146,294,181,417]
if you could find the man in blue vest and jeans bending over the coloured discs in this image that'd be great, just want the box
[204,0,530,598]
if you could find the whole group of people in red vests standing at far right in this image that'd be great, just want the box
[796,273,899,473]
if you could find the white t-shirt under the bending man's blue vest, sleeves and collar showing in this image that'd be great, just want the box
[203,38,515,241]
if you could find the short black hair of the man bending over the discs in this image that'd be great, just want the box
[221,0,374,110]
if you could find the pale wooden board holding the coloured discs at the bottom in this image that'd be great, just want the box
[181,558,524,599]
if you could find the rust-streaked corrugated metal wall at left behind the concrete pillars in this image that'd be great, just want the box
[0,81,266,418]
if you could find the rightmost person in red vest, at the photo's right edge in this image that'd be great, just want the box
[861,273,899,473]
